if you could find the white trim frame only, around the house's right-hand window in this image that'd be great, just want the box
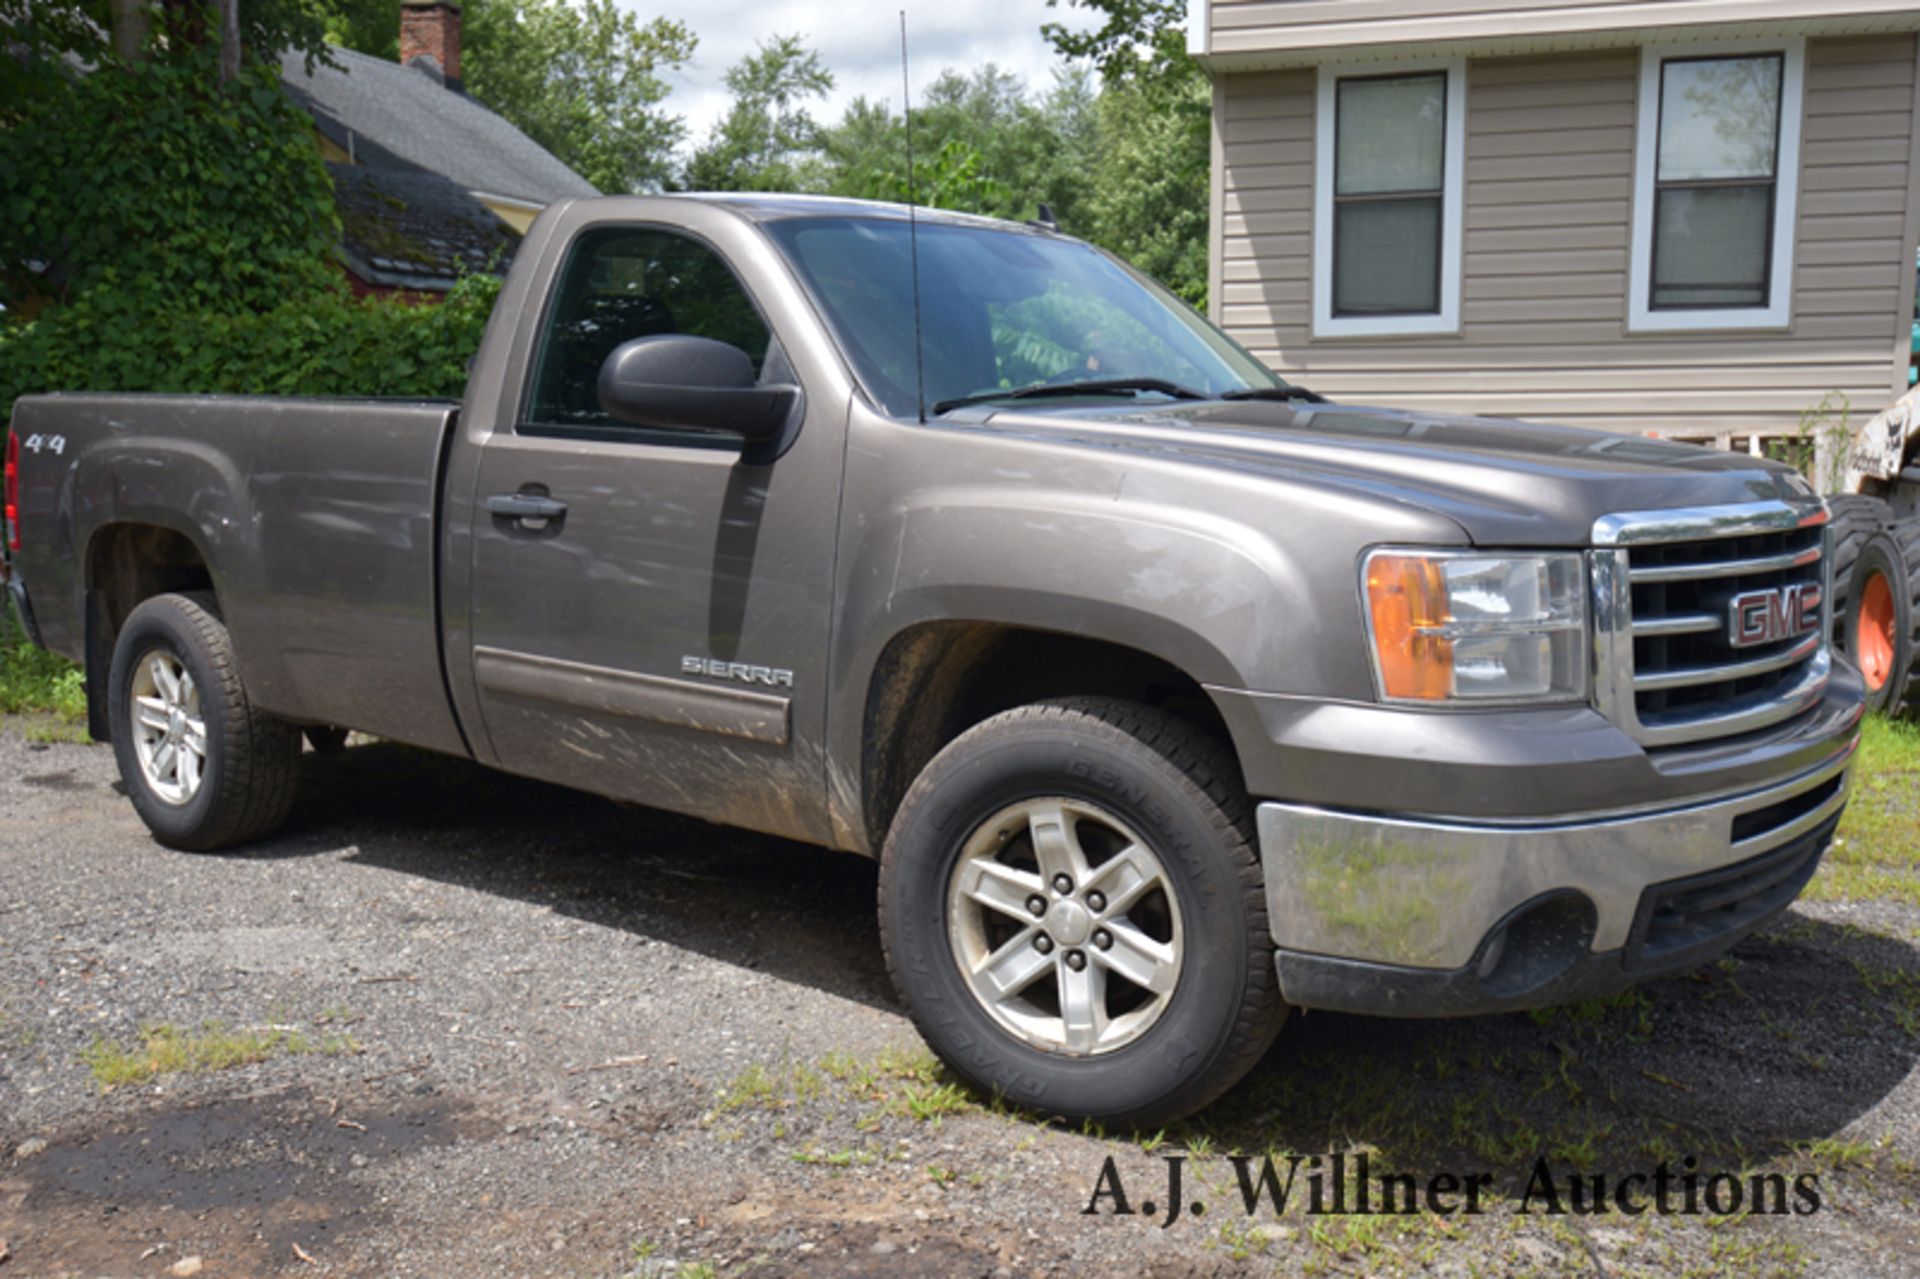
[1626,36,1807,332]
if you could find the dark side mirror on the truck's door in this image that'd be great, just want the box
[599,332,801,444]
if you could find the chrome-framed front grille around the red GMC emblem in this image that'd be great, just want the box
[1594,503,1832,745]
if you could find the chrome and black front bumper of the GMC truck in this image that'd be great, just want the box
[1258,720,1859,1016]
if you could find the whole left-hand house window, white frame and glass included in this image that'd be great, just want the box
[1313,63,1465,336]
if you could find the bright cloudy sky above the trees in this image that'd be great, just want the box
[637,0,1094,140]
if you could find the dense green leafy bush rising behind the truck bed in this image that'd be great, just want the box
[0,36,499,411]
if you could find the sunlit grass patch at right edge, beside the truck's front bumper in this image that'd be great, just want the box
[1807,716,1920,906]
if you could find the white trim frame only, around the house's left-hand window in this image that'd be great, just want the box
[1313,58,1467,338]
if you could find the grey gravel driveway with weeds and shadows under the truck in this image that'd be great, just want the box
[0,728,1920,1279]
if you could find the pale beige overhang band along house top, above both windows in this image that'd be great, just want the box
[1204,0,1914,61]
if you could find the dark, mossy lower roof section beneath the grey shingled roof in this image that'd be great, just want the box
[326,165,520,292]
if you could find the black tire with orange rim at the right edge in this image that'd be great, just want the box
[1828,495,1914,711]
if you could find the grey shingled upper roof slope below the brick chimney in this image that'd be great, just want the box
[280,48,599,204]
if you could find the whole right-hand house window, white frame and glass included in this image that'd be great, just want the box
[1630,46,1801,330]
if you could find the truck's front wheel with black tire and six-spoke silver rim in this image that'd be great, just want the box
[879,697,1286,1127]
